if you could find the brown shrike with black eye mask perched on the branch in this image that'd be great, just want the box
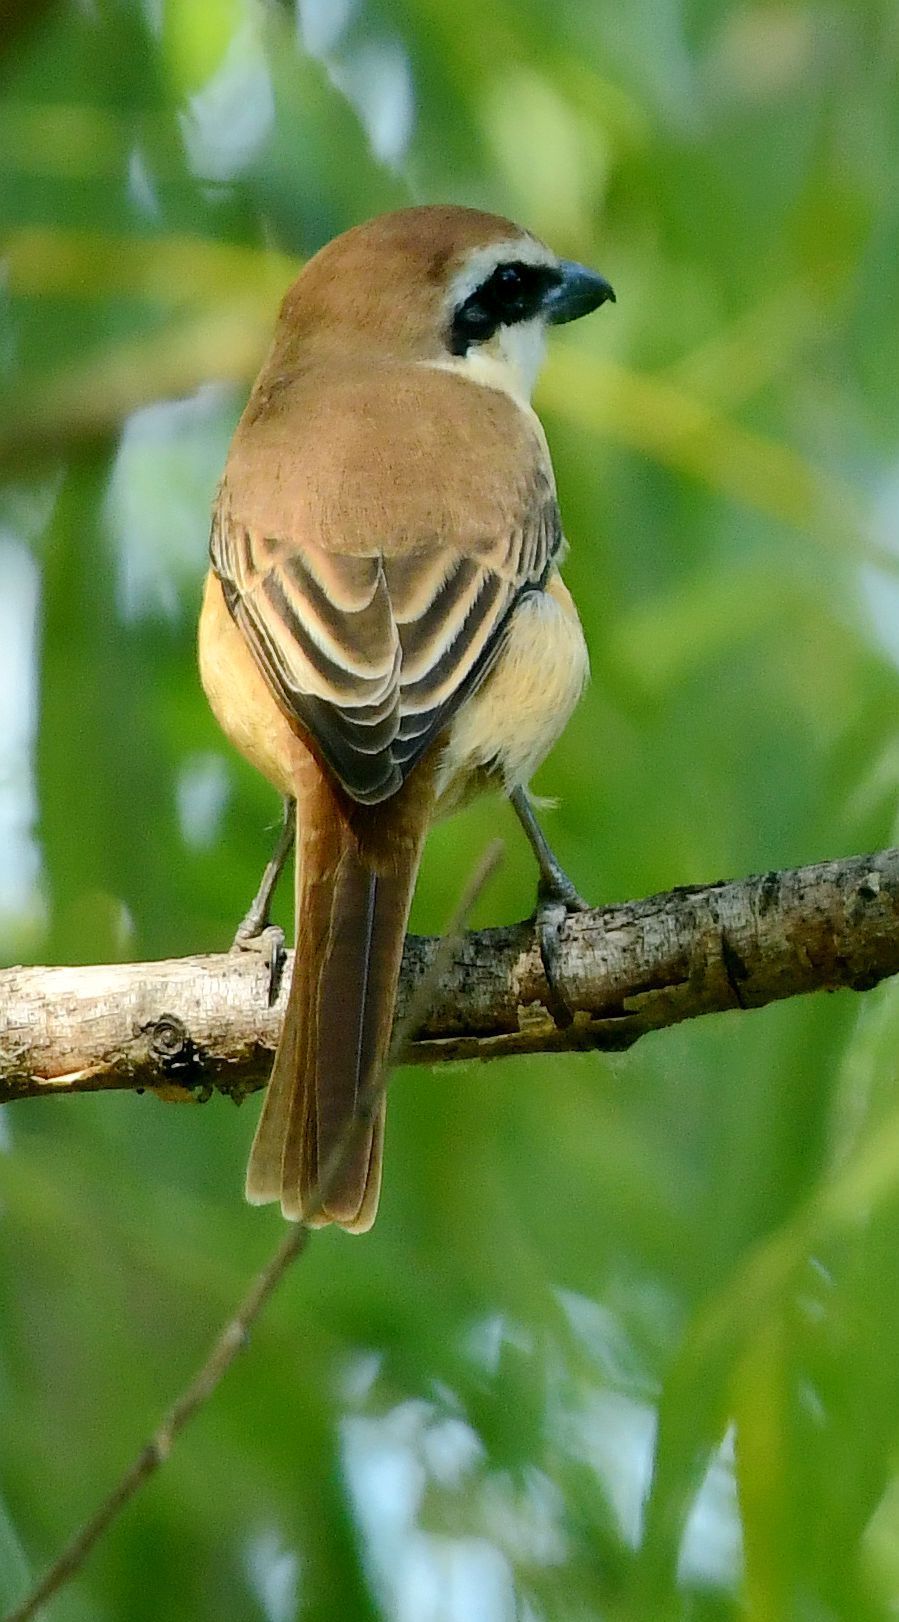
[198,204,615,1233]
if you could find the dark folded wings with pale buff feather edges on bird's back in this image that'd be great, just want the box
[209,475,561,805]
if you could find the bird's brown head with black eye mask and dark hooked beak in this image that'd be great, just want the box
[276,206,615,397]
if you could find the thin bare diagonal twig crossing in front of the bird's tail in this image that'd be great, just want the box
[3,840,503,1622]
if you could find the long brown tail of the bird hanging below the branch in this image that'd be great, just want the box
[247,767,432,1233]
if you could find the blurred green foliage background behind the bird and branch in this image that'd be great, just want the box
[0,0,899,1622]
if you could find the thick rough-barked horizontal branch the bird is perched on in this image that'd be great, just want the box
[0,848,899,1103]
